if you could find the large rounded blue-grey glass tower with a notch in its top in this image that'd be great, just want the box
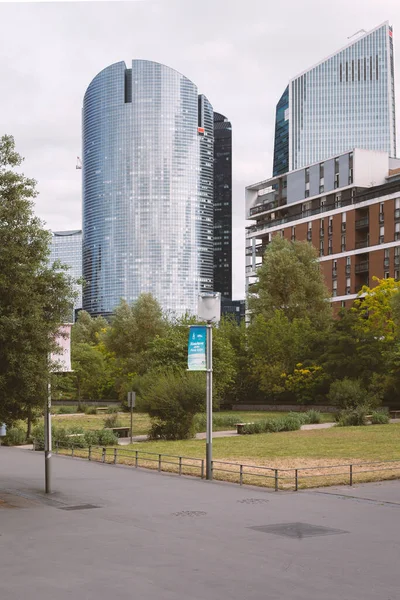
[82,60,214,315]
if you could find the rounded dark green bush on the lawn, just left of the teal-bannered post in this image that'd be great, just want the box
[140,371,205,440]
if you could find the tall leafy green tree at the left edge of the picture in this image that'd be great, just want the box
[0,136,73,423]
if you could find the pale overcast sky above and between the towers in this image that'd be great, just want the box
[0,0,400,298]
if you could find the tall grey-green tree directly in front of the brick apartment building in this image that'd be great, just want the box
[249,236,332,328]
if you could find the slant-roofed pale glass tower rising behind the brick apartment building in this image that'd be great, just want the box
[273,22,396,175]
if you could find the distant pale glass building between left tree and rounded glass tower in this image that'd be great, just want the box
[49,230,82,318]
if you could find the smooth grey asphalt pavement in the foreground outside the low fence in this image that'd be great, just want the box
[0,447,400,600]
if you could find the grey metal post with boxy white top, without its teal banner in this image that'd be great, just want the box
[197,292,221,480]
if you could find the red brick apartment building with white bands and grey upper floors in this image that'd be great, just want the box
[246,149,400,308]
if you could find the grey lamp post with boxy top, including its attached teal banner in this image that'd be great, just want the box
[188,292,221,479]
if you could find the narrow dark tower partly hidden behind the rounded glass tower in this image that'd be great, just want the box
[214,112,232,298]
